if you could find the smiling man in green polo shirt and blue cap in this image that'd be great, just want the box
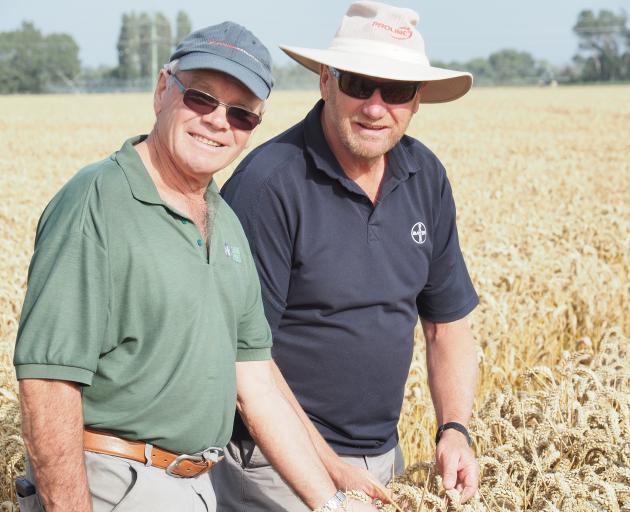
[14,22,374,512]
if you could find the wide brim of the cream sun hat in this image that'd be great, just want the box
[280,46,473,103]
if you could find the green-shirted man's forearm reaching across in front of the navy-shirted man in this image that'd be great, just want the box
[237,363,336,508]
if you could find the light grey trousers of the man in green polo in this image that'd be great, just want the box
[19,452,221,512]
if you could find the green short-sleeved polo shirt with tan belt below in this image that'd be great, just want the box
[14,137,271,453]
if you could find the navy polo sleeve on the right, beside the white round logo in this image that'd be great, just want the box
[416,174,479,323]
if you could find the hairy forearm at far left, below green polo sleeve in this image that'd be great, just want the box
[20,379,92,512]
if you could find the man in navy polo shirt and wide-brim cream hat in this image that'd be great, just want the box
[213,1,479,512]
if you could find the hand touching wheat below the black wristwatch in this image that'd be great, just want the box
[435,429,479,503]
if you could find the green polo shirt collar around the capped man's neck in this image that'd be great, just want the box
[113,135,219,209]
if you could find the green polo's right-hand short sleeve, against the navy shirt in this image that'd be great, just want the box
[236,242,272,361]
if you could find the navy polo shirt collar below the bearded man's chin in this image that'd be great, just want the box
[304,100,420,195]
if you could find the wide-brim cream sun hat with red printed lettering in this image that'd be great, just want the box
[280,0,473,103]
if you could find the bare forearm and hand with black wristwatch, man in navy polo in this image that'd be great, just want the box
[421,318,479,503]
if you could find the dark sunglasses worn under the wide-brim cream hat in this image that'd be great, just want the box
[328,67,420,105]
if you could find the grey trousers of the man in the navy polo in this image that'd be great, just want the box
[210,441,404,512]
